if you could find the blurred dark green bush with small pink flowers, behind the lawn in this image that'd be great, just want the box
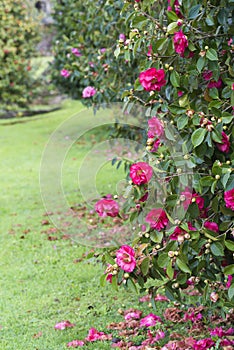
[53,0,141,106]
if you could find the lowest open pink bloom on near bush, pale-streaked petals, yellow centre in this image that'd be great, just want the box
[116,245,136,272]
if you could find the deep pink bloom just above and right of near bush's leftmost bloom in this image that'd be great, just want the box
[129,162,153,185]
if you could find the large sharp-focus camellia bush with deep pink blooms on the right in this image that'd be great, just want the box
[92,0,234,307]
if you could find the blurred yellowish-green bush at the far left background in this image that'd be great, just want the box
[0,0,39,110]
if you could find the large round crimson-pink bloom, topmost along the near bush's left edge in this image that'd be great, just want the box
[139,68,166,91]
